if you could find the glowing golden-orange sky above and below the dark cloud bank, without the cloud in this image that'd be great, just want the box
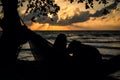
[29,0,120,30]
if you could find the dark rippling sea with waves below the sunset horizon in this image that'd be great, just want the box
[18,30,120,60]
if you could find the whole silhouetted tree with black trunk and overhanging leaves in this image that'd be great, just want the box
[0,0,120,67]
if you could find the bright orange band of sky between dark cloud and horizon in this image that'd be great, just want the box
[30,7,120,30]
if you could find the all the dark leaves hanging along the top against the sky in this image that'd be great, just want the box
[15,0,120,22]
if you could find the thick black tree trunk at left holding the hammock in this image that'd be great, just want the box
[0,0,22,80]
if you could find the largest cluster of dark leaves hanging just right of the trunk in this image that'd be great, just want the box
[18,0,60,22]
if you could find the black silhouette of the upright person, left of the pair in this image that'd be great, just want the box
[53,34,67,60]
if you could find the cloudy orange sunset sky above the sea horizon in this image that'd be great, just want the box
[0,0,120,30]
